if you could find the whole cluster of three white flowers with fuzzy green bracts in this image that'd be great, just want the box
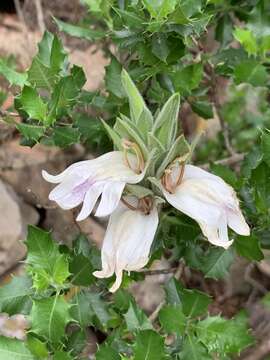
[43,71,250,292]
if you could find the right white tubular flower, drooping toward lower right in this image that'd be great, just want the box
[163,165,250,249]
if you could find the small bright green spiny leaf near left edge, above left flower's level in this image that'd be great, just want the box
[19,86,47,123]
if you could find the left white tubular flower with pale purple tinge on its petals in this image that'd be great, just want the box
[42,151,144,221]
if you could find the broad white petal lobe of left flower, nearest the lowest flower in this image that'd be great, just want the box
[95,181,126,216]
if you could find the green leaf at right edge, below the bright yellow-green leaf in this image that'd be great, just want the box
[234,60,268,86]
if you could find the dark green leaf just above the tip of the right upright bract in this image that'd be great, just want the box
[171,63,203,94]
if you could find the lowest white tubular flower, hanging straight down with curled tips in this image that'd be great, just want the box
[94,199,158,292]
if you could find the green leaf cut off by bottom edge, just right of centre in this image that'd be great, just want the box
[134,330,166,360]
